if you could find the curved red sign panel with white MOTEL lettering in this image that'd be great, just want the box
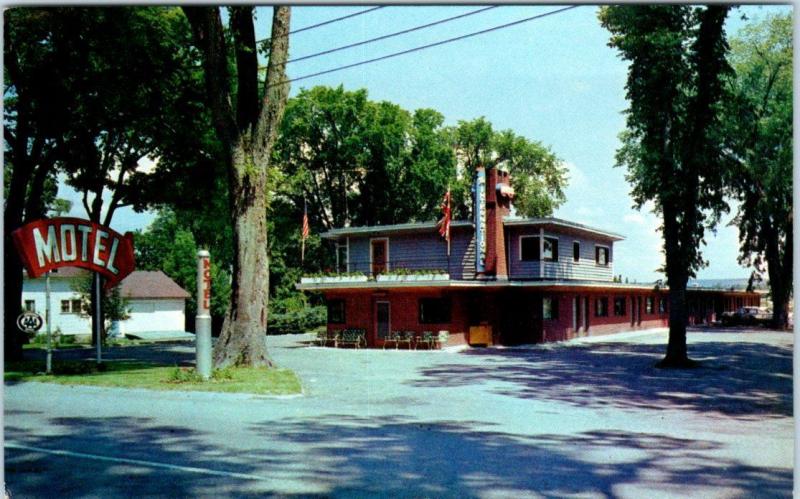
[11,218,134,288]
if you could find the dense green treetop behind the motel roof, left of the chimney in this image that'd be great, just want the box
[276,86,455,229]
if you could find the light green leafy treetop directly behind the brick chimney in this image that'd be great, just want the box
[449,117,567,218]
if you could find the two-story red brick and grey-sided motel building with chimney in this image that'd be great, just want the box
[298,168,759,347]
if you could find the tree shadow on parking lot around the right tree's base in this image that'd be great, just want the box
[409,341,792,419]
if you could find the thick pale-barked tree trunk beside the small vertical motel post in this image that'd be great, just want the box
[214,141,272,368]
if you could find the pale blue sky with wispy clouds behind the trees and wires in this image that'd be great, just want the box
[61,6,791,282]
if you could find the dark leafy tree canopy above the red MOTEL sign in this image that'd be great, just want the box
[5,7,203,356]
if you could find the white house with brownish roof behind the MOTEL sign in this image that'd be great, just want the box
[22,267,189,335]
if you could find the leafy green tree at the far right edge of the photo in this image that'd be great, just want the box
[725,14,794,328]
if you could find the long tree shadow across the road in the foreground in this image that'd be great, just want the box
[6,415,792,498]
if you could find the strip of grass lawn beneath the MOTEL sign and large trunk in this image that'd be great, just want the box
[5,361,301,395]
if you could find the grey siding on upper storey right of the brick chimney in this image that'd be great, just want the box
[509,228,614,281]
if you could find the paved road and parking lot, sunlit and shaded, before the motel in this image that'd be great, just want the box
[5,331,793,498]
